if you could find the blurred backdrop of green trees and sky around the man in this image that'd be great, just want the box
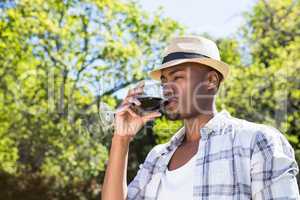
[0,0,300,200]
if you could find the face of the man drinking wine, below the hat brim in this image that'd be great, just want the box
[161,63,219,120]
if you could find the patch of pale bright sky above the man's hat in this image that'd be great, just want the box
[139,0,257,37]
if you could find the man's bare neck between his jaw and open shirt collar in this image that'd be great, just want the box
[184,110,216,143]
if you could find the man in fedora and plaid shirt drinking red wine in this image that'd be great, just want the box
[102,37,300,200]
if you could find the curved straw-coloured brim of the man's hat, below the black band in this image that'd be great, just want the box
[149,58,229,81]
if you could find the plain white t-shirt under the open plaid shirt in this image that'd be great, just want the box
[157,155,196,200]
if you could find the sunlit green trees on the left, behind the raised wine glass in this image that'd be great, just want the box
[0,0,183,199]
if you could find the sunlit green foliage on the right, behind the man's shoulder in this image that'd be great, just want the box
[218,0,300,180]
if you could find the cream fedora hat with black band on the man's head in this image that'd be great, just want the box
[149,36,229,81]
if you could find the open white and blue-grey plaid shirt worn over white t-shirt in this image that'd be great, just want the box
[127,110,300,200]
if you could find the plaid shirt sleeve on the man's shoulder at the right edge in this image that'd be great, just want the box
[251,128,300,200]
